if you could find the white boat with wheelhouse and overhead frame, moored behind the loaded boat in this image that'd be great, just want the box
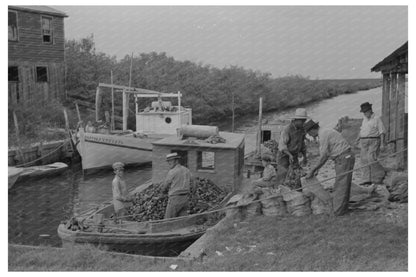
[73,83,192,171]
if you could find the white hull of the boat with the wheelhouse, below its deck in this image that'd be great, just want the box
[77,131,165,170]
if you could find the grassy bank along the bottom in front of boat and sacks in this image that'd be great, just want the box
[9,207,408,271]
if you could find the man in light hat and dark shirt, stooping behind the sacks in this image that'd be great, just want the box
[277,108,308,189]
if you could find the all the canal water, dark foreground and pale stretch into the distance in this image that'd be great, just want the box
[8,88,381,246]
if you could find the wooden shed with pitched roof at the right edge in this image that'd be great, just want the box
[371,42,408,169]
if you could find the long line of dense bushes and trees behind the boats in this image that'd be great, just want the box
[65,37,381,126]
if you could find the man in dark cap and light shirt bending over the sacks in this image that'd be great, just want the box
[305,120,355,215]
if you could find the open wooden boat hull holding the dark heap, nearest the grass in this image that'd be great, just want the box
[58,182,231,256]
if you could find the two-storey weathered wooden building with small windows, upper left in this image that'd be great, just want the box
[8,6,67,105]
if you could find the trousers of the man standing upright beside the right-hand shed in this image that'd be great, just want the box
[360,138,385,183]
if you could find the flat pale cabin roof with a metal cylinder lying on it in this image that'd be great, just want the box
[153,132,245,149]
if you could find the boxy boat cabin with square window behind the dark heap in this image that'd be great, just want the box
[152,132,245,192]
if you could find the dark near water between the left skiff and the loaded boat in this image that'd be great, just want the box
[9,164,152,246]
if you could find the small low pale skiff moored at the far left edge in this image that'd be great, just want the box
[8,162,68,189]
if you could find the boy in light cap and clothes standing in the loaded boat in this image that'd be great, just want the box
[112,162,132,217]
